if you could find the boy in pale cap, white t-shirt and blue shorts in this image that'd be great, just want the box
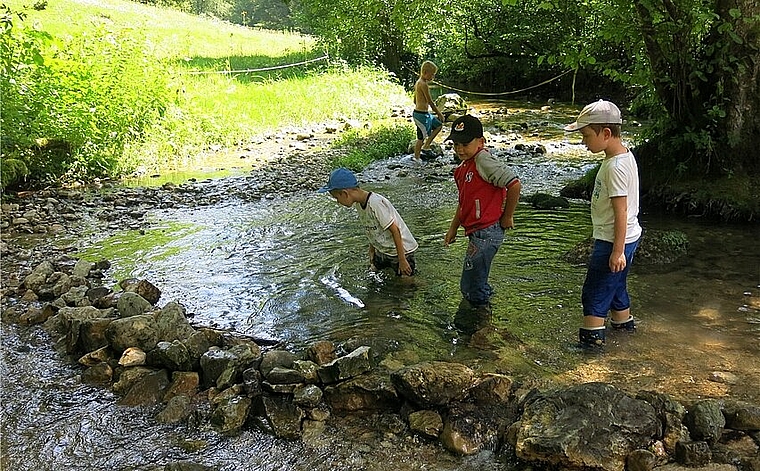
[565,100,642,350]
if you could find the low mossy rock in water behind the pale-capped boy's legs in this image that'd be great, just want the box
[563,229,689,265]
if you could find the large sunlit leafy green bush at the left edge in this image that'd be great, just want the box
[0,6,172,186]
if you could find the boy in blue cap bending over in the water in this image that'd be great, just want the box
[317,168,418,276]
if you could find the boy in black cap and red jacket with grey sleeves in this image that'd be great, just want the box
[443,115,521,324]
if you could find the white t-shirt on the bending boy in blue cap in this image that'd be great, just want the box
[354,193,418,257]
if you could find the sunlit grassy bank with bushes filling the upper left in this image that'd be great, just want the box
[0,0,408,186]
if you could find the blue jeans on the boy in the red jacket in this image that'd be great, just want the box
[459,222,504,307]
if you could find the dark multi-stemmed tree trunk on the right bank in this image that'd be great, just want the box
[634,0,760,181]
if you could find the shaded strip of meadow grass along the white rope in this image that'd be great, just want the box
[174,52,327,83]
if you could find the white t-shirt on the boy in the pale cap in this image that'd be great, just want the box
[591,151,641,244]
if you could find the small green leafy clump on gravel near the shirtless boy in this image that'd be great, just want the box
[332,124,414,172]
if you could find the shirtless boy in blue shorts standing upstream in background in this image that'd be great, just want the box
[412,61,444,160]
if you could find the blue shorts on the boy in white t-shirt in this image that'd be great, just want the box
[581,238,641,318]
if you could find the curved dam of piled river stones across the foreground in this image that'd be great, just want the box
[2,256,760,471]
